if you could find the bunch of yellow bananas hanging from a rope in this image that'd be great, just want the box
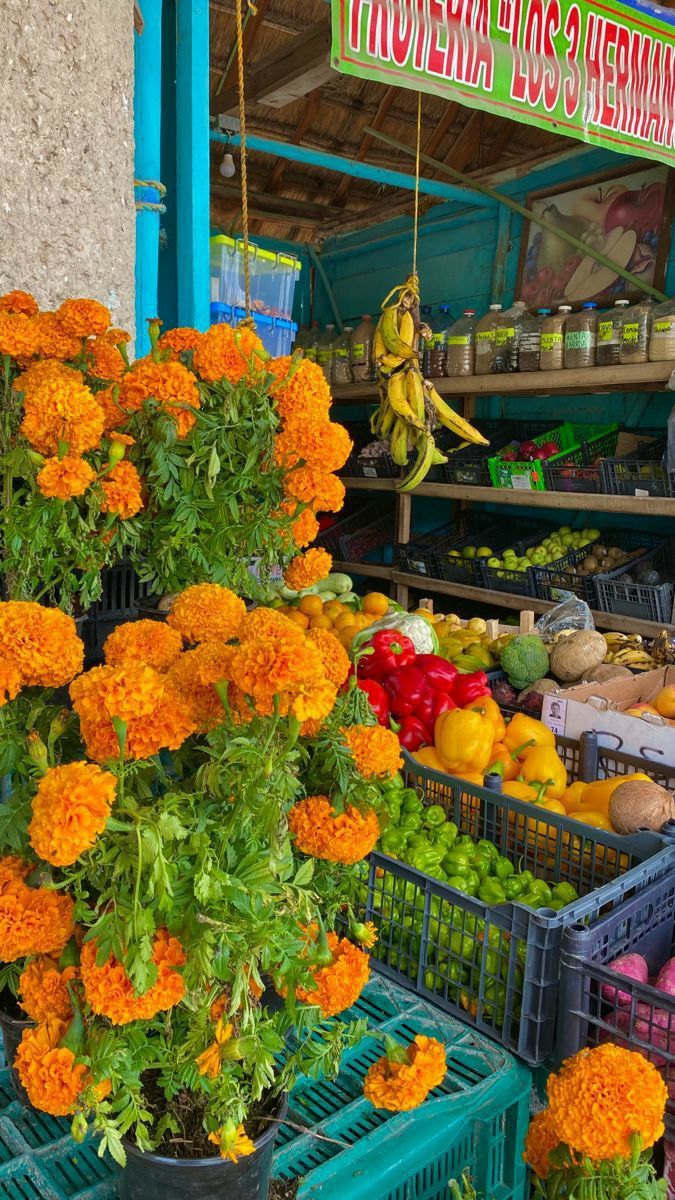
[370,275,489,492]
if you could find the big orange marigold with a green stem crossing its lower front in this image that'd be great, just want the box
[70,662,195,762]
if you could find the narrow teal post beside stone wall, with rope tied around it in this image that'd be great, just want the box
[133,0,162,356]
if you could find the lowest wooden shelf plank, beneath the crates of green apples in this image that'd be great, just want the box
[333,563,674,637]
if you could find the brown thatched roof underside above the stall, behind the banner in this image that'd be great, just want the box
[210,0,571,242]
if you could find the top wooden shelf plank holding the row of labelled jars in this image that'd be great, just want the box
[333,362,675,404]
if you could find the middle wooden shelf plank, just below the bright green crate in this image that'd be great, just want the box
[342,479,675,517]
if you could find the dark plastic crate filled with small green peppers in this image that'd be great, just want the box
[358,766,675,1064]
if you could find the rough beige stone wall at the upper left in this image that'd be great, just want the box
[0,0,136,331]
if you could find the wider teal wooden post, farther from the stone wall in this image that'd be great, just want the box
[175,0,210,329]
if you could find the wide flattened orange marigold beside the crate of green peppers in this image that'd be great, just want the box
[288,796,380,865]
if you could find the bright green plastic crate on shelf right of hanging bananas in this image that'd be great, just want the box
[488,421,619,492]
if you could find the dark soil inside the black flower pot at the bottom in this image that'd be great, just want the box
[142,1072,281,1156]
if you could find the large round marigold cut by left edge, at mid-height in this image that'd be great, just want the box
[0,600,84,688]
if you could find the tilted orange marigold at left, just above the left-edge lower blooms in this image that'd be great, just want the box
[28,762,117,866]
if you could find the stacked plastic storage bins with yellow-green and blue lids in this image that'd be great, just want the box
[211,234,300,356]
